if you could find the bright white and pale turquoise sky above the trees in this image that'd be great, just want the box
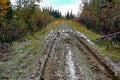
[11,0,81,15]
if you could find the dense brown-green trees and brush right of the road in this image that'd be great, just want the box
[78,0,120,34]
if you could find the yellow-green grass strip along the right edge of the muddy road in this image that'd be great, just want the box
[67,21,120,66]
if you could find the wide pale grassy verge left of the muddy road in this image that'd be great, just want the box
[0,22,58,80]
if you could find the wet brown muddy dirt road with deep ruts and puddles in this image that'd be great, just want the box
[32,23,120,80]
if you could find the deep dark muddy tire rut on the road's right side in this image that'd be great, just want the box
[74,31,120,80]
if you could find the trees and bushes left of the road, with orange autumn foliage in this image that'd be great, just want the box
[0,0,54,43]
